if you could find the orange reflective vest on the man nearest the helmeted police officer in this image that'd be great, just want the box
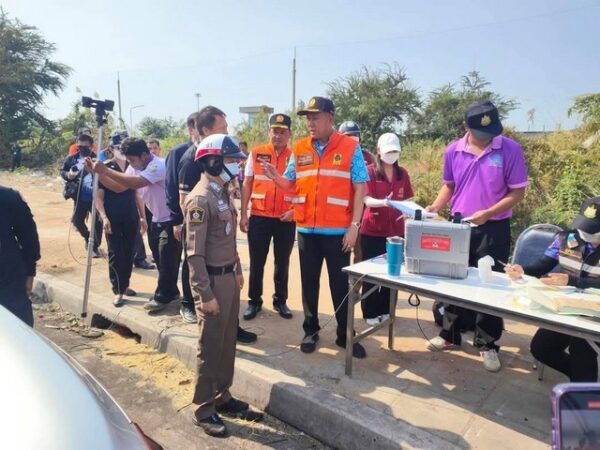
[250,144,294,218]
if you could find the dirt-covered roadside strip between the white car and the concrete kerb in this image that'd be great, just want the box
[34,304,326,450]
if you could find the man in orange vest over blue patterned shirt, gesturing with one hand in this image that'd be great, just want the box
[262,97,369,358]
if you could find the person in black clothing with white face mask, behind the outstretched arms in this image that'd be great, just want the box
[97,148,146,307]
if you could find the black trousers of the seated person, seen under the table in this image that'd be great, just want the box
[531,328,598,383]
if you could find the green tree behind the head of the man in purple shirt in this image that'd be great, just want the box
[408,71,518,142]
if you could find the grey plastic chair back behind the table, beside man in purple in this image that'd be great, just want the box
[512,223,563,381]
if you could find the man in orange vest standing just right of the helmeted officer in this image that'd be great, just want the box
[240,114,296,320]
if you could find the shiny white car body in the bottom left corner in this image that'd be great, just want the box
[0,306,162,450]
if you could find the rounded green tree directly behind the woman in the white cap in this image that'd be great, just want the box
[327,64,421,151]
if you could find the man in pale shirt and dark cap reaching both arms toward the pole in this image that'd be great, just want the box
[88,138,180,312]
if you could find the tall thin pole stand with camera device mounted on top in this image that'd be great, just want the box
[81,97,115,319]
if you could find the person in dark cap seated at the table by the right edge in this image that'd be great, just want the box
[505,197,600,383]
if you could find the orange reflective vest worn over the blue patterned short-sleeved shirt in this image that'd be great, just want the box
[293,131,356,228]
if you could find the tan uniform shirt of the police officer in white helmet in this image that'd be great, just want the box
[184,176,242,303]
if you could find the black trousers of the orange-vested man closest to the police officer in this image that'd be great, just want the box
[248,216,296,305]
